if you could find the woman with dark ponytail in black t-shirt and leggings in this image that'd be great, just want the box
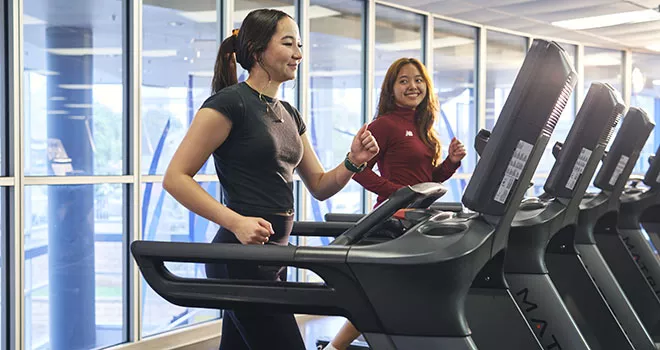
[163,9,378,350]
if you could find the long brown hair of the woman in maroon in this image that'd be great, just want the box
[376,58,442,166]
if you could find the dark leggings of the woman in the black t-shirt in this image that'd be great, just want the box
[206,214,305,350]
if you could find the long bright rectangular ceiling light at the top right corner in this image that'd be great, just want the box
[552,10,660,30]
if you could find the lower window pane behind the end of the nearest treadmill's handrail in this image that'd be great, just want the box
[141,182,220,337]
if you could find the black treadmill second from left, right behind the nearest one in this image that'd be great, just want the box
[480,83,628,350]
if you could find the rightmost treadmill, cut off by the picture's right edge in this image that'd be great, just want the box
[594,142,660,342]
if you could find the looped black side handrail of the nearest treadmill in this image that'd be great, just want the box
[131,241,376,322]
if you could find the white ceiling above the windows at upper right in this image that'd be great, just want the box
[404,0,660,51]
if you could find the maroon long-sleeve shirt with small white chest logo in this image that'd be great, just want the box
[353,107,460,207]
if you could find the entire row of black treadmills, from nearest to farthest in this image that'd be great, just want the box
[131,39,660,350]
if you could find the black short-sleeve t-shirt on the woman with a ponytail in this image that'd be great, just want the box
[201,82,306,214]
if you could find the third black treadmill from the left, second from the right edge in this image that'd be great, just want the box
[544,107,654,350]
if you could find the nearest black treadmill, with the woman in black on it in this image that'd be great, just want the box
[131,39,577,350]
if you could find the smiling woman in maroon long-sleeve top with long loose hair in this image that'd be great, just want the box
[325,58,466,350]
